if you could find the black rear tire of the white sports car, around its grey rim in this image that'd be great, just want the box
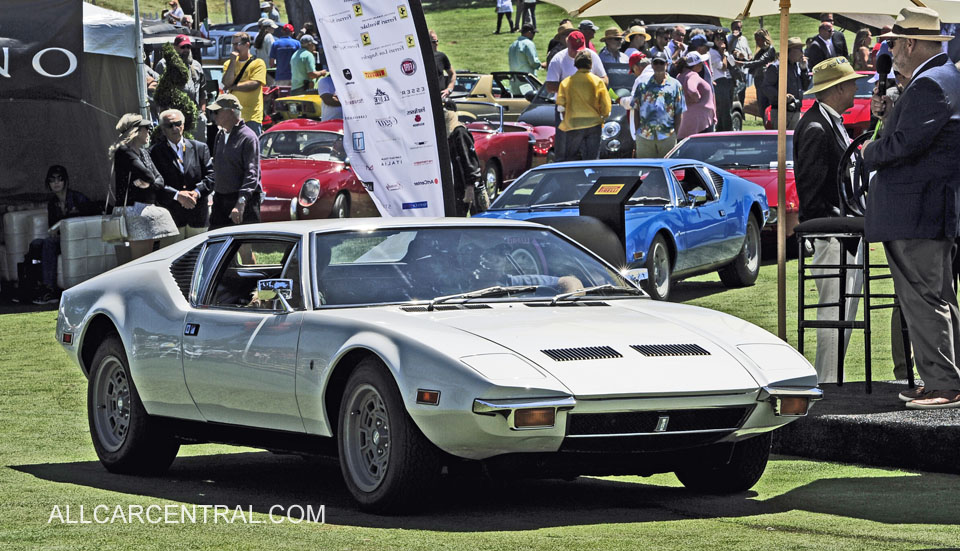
[87,334,180,475]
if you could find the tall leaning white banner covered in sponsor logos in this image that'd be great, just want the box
[311,0,452,216]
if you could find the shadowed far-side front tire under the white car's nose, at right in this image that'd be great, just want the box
[675,432,773,494]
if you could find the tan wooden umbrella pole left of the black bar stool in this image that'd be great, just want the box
[777,0,788,341]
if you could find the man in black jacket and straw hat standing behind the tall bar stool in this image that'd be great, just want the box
[793,57,867,383]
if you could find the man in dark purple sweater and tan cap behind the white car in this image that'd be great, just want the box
[197,94,261,230]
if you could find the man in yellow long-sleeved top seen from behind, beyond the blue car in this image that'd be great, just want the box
[556,50,610,161]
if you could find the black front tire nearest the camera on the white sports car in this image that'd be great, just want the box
[337,358,443,514]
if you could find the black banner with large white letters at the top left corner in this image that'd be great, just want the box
[0,0,83,100]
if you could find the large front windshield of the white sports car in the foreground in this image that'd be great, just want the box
[314,226,636,306]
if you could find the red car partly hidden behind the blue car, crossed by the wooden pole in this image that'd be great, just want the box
[667,130,800,244]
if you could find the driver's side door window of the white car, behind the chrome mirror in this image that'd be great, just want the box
[203,239,303,310]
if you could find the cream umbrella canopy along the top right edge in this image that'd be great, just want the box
[544,0,960,23]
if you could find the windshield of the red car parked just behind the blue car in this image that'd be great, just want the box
[670,134,793,169]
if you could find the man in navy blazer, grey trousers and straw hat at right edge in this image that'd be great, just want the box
[863,7,960,409]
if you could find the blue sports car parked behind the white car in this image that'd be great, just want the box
[480,159,769,300]
